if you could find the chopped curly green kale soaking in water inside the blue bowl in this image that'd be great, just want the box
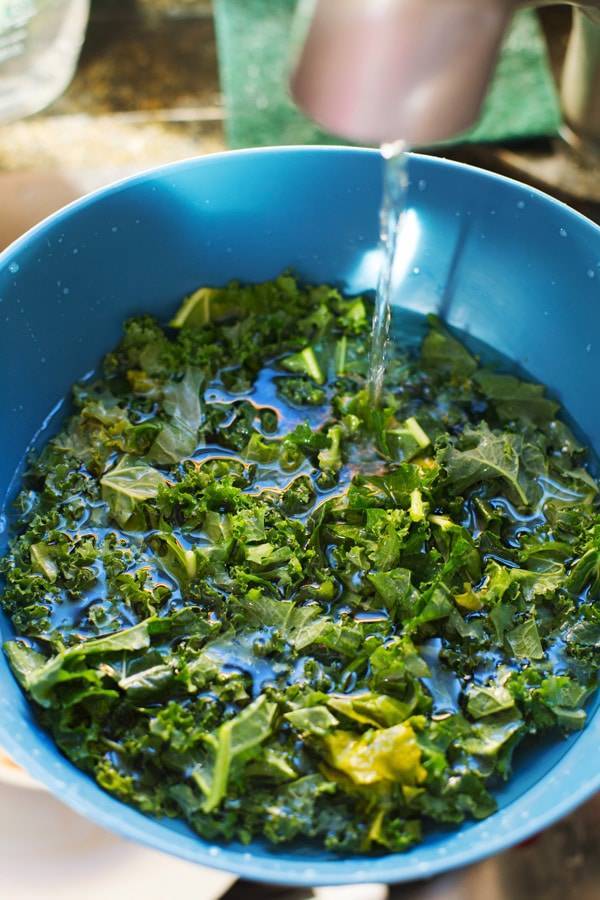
[0,275,600,853]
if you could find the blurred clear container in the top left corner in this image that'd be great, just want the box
[0,0,90,122]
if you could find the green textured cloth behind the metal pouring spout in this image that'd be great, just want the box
[215,0,560,147]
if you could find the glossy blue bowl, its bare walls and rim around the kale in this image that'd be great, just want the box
[0,148,600,885]
